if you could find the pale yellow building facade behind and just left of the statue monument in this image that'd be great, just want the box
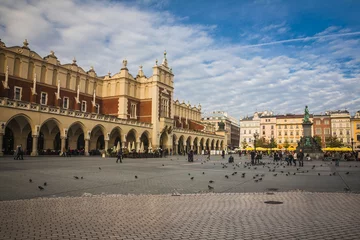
[276,114,313,148]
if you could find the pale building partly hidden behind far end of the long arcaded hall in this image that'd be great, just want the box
[202,111,240,149]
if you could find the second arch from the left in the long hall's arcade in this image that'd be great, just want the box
[38,118,63,153]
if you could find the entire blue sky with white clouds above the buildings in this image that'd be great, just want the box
[0,0,360,118]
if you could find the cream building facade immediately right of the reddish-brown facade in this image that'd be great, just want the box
[328,110,351,146]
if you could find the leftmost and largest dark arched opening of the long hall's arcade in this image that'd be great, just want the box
[3,114,32,154]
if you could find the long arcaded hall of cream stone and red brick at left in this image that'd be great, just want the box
[0,40,227,156]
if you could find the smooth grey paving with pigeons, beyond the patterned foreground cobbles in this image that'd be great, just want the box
[0,156,360,200]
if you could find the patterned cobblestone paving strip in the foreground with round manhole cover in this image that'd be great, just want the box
[0,192,360,240]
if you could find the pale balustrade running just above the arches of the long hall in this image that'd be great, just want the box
[0,98,152,128]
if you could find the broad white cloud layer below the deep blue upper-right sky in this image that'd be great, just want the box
[0,0,360,117]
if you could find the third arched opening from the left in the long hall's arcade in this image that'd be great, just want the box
[66,122,85,151]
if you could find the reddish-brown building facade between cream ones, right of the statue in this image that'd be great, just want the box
[313,114,331,148]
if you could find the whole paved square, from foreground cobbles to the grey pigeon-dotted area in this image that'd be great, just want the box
[0,156,360,239]
